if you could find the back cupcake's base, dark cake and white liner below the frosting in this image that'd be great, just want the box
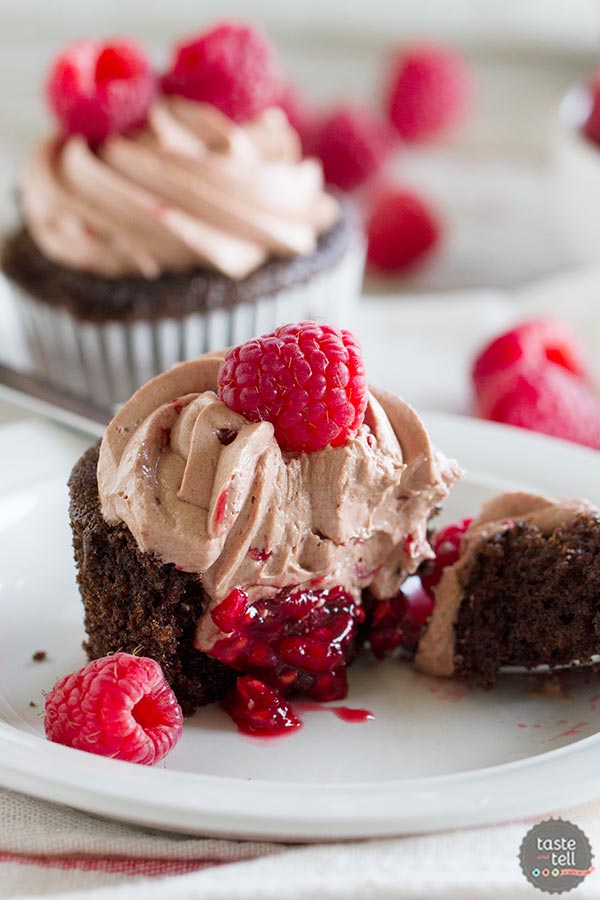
[1,213,364,405]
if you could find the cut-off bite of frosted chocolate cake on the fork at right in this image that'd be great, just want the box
[415,492,600,687]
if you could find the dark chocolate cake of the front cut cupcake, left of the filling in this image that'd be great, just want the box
[69,445,236,715]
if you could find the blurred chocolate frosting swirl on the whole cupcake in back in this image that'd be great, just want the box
[21,97,340,279]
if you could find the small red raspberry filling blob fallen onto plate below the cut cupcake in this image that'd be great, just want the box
[221,675,302,737]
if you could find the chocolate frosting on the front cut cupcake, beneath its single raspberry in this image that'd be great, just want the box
[98,353,460,640]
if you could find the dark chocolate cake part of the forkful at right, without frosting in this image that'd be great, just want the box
[455,514,600,687]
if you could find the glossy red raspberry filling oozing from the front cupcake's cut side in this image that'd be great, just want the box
[210,587,364,702]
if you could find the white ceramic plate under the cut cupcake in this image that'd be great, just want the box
[0,415,600,840]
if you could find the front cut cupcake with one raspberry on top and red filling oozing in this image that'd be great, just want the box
[70,322,460,713]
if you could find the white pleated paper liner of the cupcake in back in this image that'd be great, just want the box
[11,240,364,405]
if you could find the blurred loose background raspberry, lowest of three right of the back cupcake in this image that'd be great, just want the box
[367,189,440,273]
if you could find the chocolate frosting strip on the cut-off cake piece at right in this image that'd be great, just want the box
[415,491,598,676]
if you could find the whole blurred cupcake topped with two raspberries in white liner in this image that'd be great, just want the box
[2,23,362,402]
